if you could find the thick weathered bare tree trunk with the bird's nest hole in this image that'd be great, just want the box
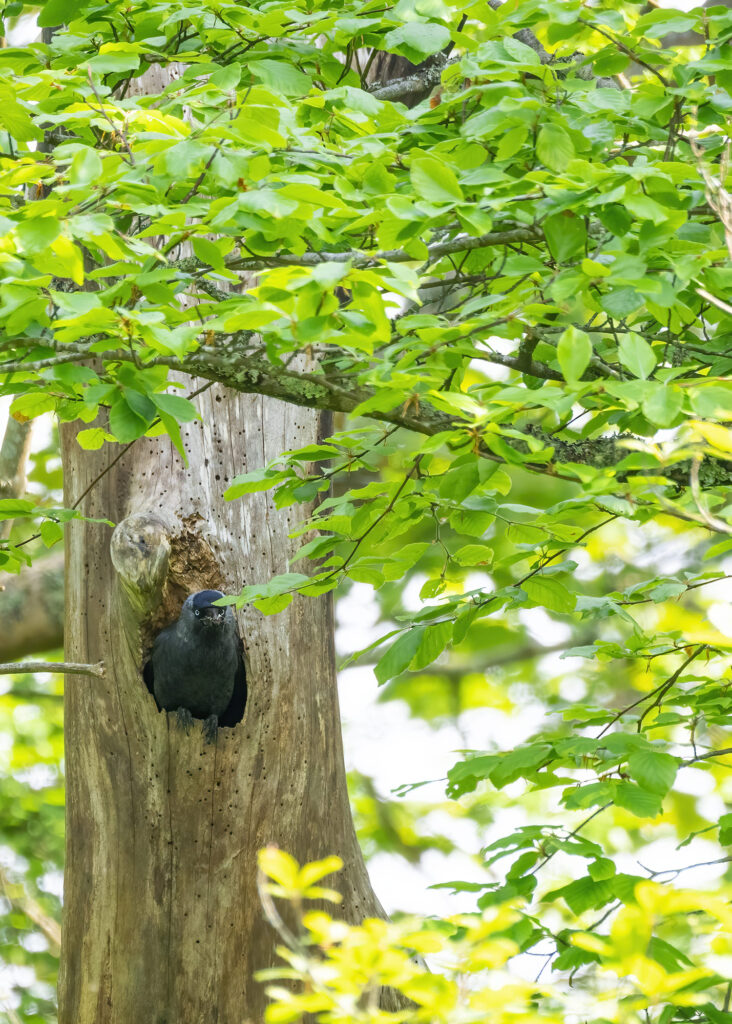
[59,386,383,1024]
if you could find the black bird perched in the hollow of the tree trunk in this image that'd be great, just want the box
[152,590,246,742]
